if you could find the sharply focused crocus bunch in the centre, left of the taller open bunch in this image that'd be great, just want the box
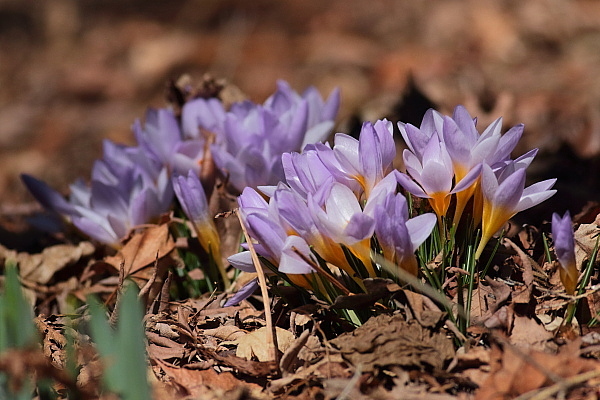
[229,120,436,300]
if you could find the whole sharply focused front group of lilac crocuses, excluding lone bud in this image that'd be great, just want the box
[229,106,555,300]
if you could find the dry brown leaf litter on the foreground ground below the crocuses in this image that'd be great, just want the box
[0,198,600,399]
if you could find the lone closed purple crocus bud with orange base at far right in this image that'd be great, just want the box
[552,211,579,295]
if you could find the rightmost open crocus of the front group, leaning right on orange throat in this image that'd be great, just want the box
[475,164,556,259]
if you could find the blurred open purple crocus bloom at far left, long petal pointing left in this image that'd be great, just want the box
[22,141,173,246]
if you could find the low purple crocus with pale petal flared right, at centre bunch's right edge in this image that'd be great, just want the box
[374,193,437,276]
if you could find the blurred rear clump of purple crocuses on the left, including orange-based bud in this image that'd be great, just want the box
[22,82,339,250]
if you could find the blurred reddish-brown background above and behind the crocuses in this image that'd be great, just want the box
[0,0,600,218]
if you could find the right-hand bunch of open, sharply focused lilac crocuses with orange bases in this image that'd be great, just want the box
[399,106,556,259]
